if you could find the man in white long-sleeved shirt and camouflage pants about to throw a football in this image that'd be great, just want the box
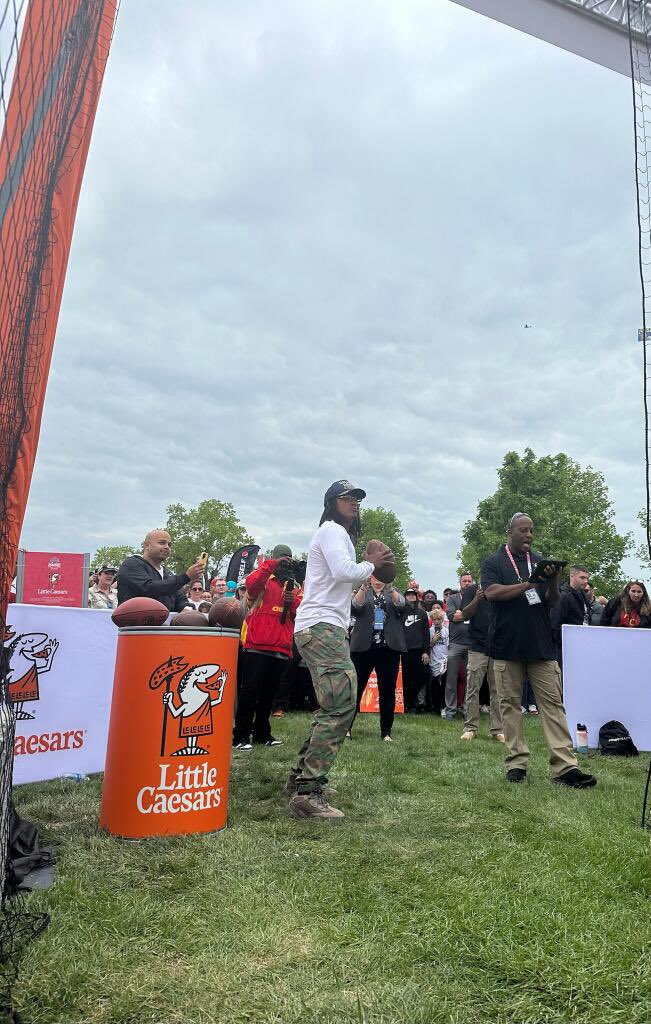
[285,480,394,820]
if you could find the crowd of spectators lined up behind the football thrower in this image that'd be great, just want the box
[94,530,651,750]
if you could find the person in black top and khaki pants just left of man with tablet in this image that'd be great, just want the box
[461,583,505,743]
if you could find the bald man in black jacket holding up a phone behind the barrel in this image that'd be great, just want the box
[118,529,204,611]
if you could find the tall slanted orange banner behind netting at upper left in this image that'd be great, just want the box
[0,0,117,620]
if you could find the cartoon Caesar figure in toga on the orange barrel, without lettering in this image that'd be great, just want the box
[163,665,228,757]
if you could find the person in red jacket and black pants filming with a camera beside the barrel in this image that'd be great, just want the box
[232,544,303,751]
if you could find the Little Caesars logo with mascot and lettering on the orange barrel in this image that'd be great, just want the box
[136,655,228,814]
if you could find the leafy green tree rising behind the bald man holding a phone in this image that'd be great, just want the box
[165,498,254,575]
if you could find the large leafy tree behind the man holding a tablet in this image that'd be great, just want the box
[459,449,632,594]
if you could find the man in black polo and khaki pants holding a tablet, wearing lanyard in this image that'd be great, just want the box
[481,512,597,790]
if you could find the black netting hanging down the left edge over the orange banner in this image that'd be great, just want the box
[0,0,116,1019]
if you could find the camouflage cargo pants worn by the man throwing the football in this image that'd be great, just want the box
[292,623,357,793]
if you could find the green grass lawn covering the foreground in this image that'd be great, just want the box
[10,715,651,1024]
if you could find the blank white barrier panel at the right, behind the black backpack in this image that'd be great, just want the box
[563,626,651,751]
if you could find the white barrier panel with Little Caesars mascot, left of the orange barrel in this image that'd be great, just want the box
[5,604,118,785]
